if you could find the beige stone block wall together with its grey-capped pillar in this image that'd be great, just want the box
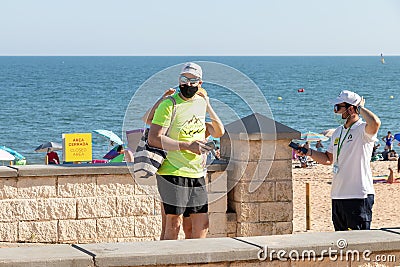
[0,113,300,243]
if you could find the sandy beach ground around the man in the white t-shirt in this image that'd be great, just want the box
[293,161,400,233]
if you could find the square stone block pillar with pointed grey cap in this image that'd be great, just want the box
[221,113,300,236]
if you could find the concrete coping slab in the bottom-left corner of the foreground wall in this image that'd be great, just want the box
[0,245,94,267]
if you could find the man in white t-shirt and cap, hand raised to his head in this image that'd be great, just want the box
[297,90,381,231]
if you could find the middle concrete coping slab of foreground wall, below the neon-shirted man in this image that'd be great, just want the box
[79,238,259,266]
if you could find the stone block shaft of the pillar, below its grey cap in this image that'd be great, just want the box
[228,141,293,236]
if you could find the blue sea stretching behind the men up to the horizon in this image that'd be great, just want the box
[0,56,400,164]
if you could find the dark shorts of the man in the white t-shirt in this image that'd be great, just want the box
[332,195,374,231]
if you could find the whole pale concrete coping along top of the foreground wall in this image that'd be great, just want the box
[0,228,400,267]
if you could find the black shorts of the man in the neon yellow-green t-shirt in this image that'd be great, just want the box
[157,175,208,217]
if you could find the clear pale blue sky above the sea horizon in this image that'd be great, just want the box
[0,0,400,56]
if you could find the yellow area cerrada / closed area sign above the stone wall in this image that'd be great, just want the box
[62,133,92,162]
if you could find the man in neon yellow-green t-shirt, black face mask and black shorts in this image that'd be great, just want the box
[146,62,224,239]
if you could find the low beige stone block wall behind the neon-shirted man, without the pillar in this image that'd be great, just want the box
[0,165,227,243]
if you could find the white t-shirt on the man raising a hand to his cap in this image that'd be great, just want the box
[327,119,377,199]
